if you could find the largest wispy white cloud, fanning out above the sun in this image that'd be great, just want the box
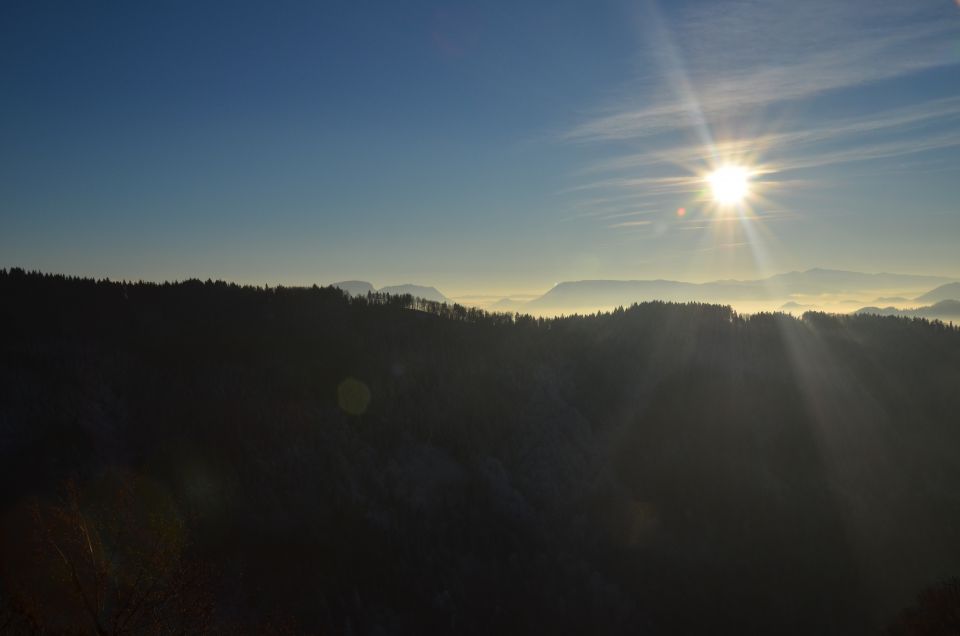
[566,0,960,141]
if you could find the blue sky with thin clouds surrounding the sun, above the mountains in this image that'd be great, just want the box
[0,0,960,298]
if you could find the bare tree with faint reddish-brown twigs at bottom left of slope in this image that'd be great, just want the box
[4,474,212,636]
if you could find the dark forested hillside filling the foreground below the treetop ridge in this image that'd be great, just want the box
[0,270,960,634]
